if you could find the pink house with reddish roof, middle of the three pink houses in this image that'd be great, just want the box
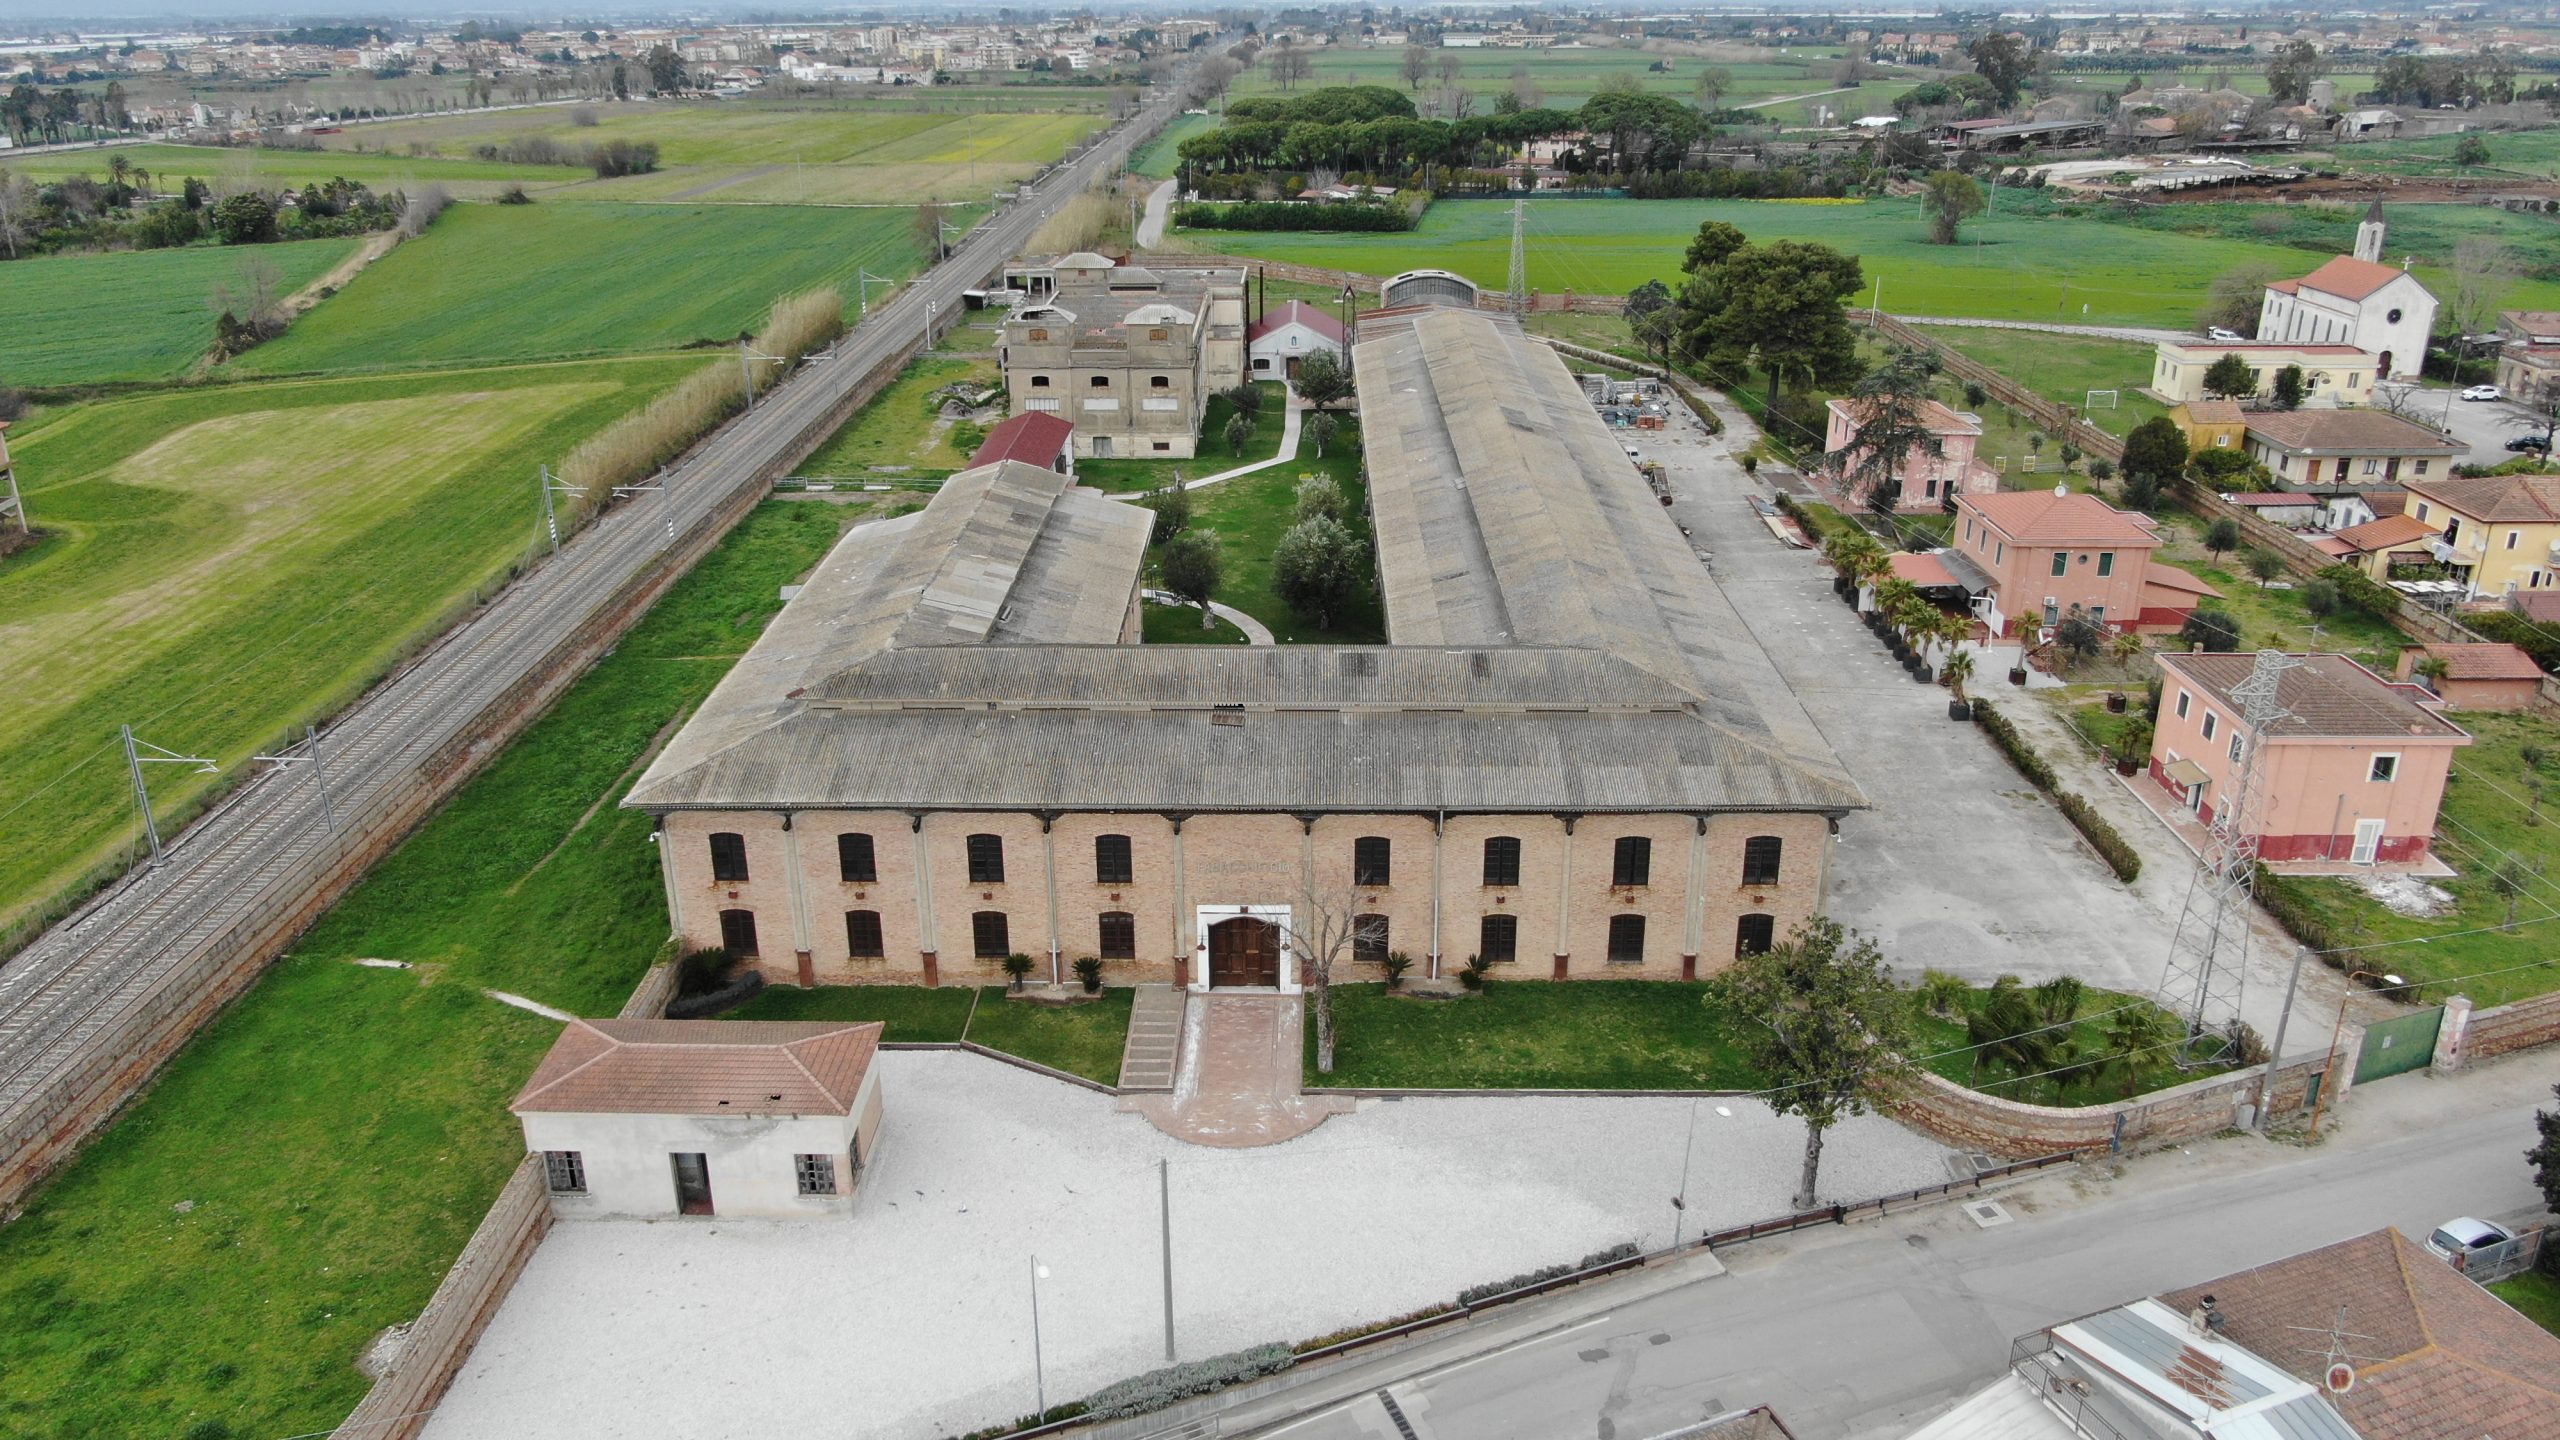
[1953,487,2217,635]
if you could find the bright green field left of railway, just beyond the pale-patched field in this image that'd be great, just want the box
[233,202,952,374]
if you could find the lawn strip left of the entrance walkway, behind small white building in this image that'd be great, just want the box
[722,984,1137,1084]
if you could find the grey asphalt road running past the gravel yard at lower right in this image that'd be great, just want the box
[1224,1056,2552,1440]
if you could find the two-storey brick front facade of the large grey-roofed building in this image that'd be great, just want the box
[658,810,1830,984]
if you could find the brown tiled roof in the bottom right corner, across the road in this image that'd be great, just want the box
[2158,1219,2560,1440]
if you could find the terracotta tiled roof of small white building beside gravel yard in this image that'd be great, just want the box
[509,1020,881,1115]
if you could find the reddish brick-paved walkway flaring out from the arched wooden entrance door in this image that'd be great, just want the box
[1121,992,1352,1150]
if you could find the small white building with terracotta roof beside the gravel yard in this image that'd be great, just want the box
[509,1020,881,1220]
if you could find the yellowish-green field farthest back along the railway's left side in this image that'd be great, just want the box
[333,92,1103,205]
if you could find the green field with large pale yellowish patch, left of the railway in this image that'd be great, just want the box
[0,356,704,942]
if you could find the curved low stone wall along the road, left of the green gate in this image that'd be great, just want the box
[1889,1040,2344,1161]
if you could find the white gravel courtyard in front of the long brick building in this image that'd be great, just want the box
[428,1051,1948,1440]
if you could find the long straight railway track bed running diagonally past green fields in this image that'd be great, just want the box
[0,67,1208,1202]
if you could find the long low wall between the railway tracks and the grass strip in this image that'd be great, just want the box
[0,327,922,1207]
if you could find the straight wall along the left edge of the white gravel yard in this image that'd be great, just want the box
[330,1142,550,1440]
